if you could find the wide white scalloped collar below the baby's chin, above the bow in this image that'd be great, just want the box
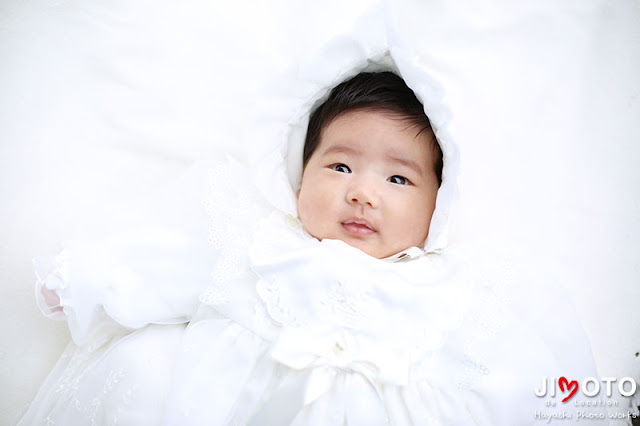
[250,212,473,368]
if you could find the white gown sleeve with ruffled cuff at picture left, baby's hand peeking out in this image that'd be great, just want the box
[34,164,218,344]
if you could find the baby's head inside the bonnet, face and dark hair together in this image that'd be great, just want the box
[298,72,442,258]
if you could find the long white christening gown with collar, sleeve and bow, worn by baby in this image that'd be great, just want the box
[20,161,602,426]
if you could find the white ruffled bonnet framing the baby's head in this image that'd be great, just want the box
[245,14,459,252]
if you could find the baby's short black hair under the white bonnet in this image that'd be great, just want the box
[302,71,442,183]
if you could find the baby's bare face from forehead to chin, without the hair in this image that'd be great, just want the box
[298,110,439,258]
